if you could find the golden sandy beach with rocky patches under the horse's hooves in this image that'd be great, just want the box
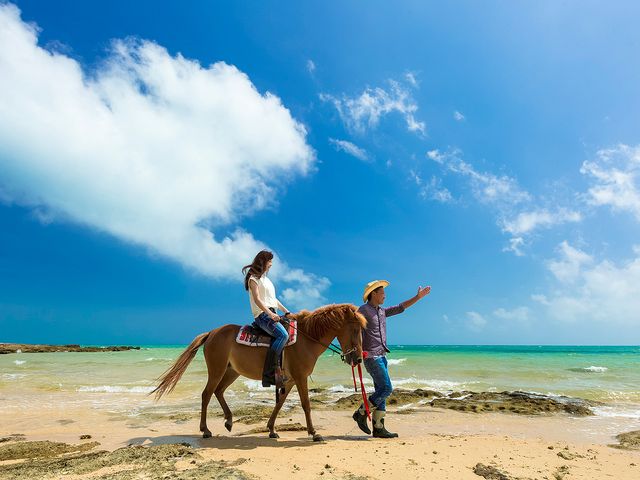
[0,390,640,480]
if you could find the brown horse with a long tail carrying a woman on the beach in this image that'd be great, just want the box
[151,304,367,442]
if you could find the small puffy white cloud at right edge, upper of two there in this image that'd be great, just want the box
[580,145,640,221]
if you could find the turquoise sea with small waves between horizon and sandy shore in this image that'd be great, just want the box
[0,345,640,418]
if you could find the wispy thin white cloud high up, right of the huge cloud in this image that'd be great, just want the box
[320,80,426,134]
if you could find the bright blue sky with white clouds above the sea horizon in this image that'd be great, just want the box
[0,0,640,345]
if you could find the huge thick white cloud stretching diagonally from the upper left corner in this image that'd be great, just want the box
[0,4,327,308]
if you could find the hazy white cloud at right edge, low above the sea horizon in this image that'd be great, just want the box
[536,242,640,328]
